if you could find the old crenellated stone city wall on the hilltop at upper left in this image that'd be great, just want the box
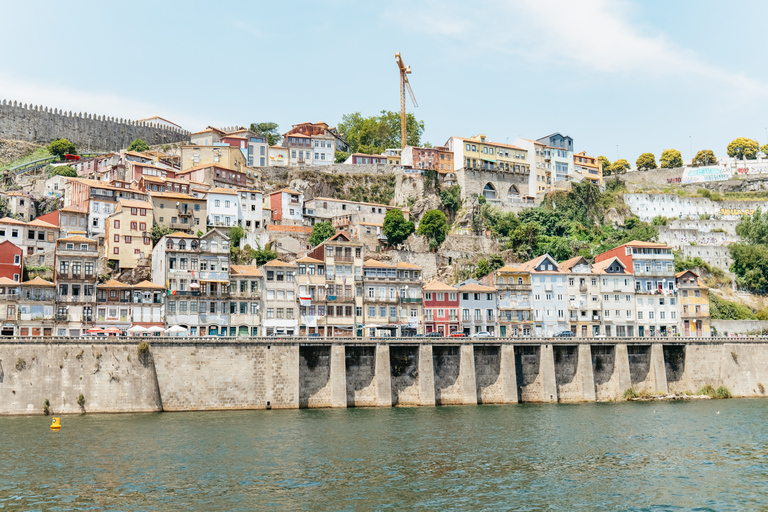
[0,100,189,151]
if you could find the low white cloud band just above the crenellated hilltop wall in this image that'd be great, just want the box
[0,74,205,131]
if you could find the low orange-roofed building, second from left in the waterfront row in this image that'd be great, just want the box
[17,277,56,338]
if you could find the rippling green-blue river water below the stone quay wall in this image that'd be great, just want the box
[0,399,768,510]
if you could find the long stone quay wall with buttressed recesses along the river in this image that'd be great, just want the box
[0,338,768,415]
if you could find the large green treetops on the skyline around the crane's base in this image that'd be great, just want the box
[338,110,424,155]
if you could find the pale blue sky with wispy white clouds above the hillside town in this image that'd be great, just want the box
[0,0,768,165]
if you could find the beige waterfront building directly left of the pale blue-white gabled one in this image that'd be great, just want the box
[490,265,533,338]
